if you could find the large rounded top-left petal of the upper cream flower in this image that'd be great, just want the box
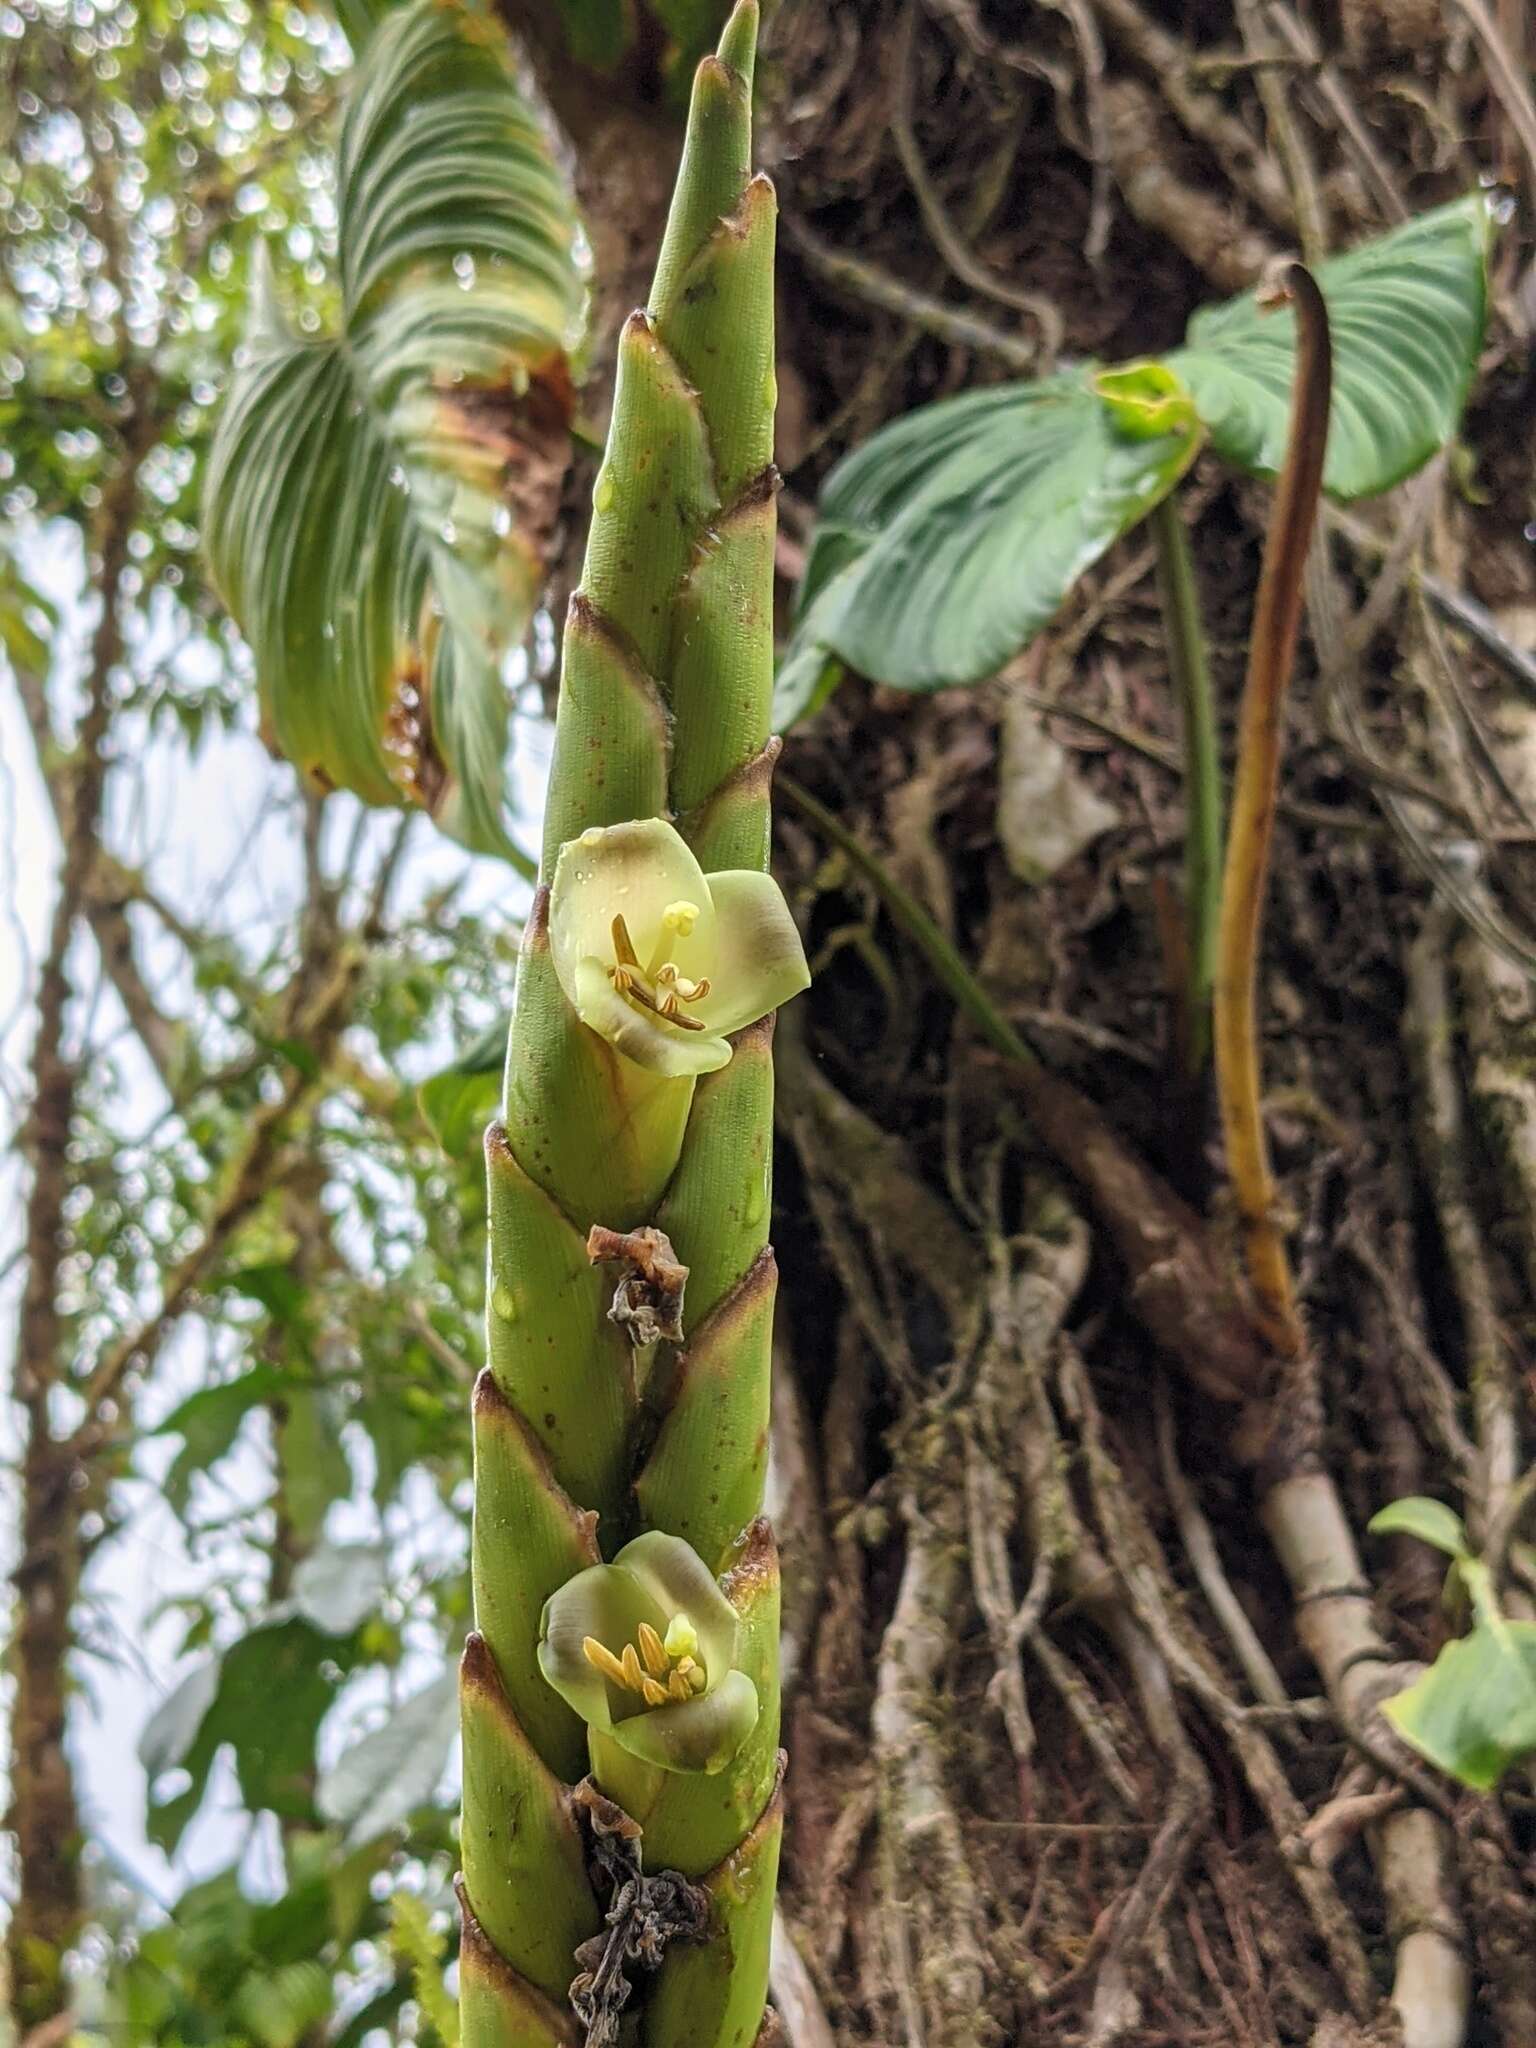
[549,817,715,1007]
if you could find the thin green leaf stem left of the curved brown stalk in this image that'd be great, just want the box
[1151,496,1221,1077]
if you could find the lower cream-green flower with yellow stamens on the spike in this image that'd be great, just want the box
[539,1530,758,1776]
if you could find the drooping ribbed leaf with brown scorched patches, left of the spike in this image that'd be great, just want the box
[205,0,582,858]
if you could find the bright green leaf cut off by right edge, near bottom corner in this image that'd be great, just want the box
[1382,1620,1536,1792]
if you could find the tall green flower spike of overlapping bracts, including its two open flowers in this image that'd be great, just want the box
[463,0,786,2048]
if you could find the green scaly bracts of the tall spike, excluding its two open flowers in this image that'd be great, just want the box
[463,0,780,2048]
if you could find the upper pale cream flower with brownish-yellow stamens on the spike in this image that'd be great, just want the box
[549,817,811,1075]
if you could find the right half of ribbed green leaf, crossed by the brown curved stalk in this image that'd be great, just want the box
[1167,193,1491,498]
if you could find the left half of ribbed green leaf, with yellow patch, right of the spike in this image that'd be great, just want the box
[774,371,1200,731]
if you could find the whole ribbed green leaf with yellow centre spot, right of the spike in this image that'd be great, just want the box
[774,193,1489,733]
